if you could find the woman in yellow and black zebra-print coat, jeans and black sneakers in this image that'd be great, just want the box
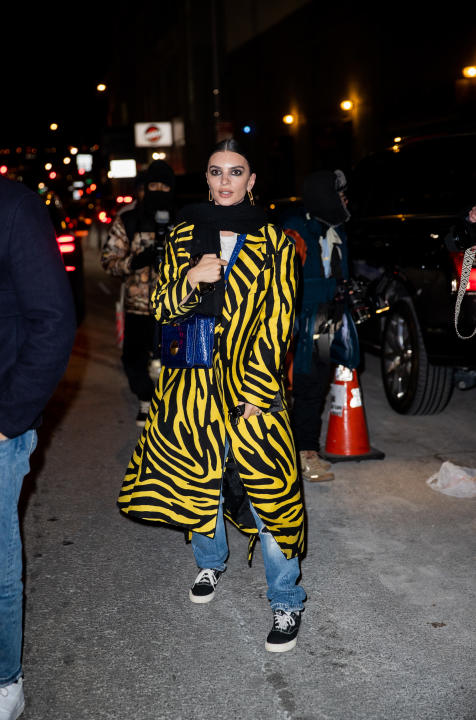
[118,140,305,652]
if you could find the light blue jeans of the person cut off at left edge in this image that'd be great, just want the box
[0,430,37,687]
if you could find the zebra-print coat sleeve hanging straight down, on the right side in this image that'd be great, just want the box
[242,231,296,410]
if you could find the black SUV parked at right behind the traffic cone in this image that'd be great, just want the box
[347,134,476,415]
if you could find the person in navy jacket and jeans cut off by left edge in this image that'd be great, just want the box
[0,178,76,720]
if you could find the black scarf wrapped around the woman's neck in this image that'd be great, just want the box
[177,200,268,317]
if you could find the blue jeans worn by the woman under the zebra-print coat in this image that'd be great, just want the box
[192,443,306,612]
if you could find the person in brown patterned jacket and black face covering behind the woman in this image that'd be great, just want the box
[101,160,175,427]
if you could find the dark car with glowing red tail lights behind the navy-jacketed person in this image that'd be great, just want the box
[43,191,85,325]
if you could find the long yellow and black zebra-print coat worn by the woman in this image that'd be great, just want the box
[118,223,304,558]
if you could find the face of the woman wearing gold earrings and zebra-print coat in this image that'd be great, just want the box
[206,150,256,205]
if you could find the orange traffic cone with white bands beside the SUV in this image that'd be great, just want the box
[320,365,385,462]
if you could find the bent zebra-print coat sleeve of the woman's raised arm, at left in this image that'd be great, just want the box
[152,223,201,325]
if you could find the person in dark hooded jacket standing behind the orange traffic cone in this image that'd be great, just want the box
[284,170,350,482]
